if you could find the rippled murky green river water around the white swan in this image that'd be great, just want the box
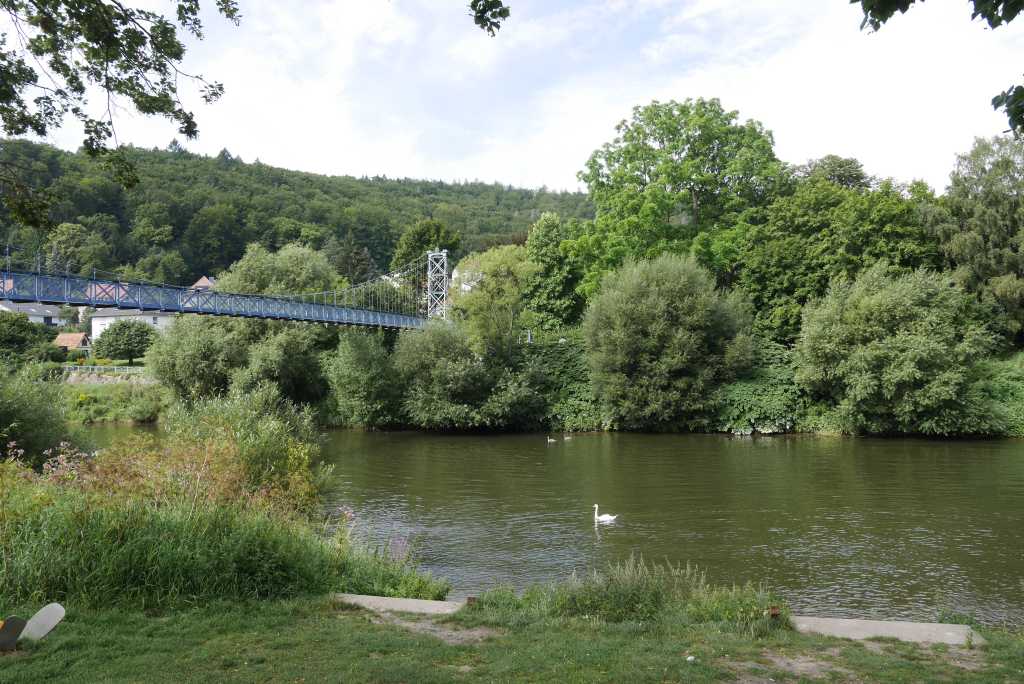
[90,431,1024,624]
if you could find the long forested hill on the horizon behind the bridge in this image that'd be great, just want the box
[0,140,593,283]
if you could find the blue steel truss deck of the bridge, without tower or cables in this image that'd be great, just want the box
[0,270,426,328]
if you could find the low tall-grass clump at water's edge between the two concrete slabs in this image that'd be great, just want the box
[466,557,788,636]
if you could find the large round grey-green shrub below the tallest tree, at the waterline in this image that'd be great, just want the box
[584,255,753,430]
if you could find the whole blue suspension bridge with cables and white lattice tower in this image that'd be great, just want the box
[0,251,449,329]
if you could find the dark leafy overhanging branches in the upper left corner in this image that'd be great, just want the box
[0,0,241,224]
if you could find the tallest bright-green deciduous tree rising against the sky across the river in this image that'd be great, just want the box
[567,99,783,295]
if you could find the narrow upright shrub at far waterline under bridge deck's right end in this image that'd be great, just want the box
[324,331,403,428]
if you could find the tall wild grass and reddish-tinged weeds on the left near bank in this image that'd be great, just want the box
[0,385,447,608]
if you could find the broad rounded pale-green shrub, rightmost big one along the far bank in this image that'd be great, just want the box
[796,263,1006,435]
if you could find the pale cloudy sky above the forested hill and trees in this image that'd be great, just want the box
[36,0,1024,191]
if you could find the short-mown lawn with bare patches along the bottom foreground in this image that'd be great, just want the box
[0,598,1024,684]
